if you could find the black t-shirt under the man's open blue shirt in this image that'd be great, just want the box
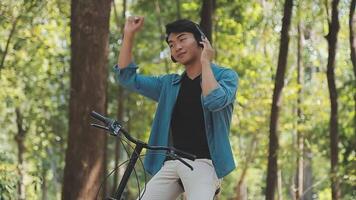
[171,74,210,159]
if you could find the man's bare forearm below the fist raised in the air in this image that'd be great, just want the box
[118,33,135,69]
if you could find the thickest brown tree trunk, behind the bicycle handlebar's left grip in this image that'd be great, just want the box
[62,0,111,200]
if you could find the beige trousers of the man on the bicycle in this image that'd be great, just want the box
[141,159,221,200]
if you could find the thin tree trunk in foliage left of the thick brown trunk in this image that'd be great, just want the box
[15,108,26,200]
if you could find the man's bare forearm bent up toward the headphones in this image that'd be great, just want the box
[201,61,219,96]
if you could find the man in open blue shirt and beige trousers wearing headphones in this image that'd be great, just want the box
[115,17,238,200]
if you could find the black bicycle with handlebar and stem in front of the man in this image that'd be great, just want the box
[90,111,196,200]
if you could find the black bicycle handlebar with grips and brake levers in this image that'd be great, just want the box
[90,111,196,170]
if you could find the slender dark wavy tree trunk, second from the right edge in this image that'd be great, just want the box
[326,0,340,200]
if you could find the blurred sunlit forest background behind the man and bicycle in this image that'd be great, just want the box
[0,0,356,200]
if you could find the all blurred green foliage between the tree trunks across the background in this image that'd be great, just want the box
[0,0,356,199]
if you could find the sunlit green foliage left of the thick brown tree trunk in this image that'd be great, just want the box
[0,0,69,199]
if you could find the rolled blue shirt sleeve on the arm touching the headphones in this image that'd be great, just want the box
[203,70,238,111]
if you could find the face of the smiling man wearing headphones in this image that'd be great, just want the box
[168,32,202,65]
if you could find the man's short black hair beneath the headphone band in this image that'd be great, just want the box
[166,19,205,62]
